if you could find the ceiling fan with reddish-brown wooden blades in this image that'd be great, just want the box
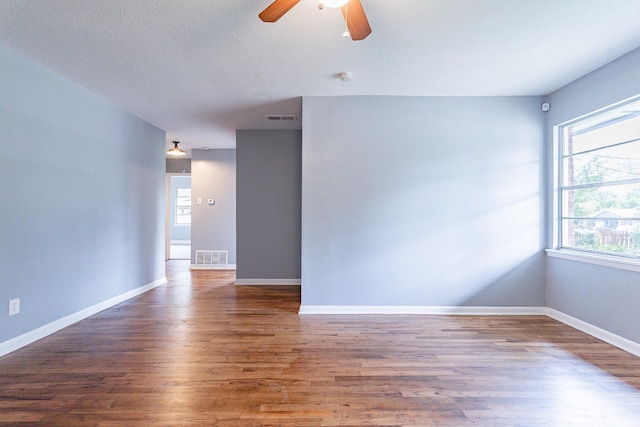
[258,0,371,41]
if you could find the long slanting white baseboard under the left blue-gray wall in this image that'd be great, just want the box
[0,277,167,357]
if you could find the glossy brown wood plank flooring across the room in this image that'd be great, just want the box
[0,261,640,427]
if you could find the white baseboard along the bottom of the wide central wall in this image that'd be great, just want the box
[298,305,546,316]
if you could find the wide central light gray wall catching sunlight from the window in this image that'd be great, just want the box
[302,96,544,307]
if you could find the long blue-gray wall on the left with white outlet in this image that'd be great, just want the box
[0,46,165,342]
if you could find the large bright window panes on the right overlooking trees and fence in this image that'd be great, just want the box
[558,99,640,258]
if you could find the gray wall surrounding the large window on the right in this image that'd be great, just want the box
[546,49,640,343]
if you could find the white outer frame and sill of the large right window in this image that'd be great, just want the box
[547,96,640,272]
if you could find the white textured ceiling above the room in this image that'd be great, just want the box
[0,0,640,154]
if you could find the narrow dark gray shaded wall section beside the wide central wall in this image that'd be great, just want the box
[236,130,302,279]
